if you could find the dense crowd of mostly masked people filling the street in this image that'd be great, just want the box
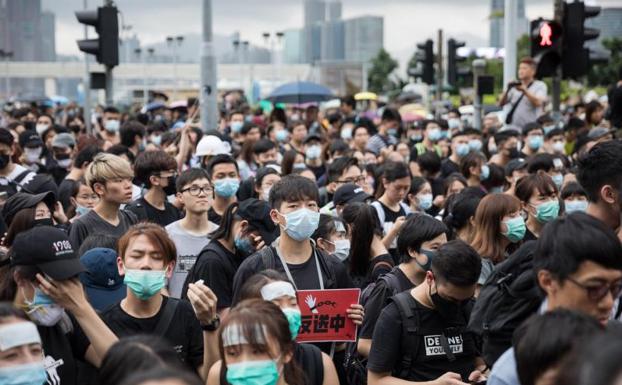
[0,58,622,385]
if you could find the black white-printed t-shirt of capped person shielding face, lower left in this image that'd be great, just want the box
[37,316,91,385]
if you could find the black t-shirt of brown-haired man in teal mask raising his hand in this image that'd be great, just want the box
[102,296,203,370]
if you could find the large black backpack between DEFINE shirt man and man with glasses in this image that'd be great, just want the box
[469,241,543,367]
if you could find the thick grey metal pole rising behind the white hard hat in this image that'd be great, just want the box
[199,0,218,132]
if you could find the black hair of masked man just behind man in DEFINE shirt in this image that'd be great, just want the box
[397,214,447,262]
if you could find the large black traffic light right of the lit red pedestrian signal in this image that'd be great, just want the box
[562,2,602,78]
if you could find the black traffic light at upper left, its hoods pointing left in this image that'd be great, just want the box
[76,6,119,67]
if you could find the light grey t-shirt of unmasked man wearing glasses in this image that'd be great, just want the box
[166,220,218,298]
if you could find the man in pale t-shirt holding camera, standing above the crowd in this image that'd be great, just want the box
[499,57,547,131]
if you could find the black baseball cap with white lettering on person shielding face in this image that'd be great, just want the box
[11,226,86,280]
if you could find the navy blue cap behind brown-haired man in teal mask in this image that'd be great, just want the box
[80,247,127,311]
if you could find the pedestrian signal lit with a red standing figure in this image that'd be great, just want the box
[530,18,562,79]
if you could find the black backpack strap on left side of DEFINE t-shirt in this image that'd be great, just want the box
[391,291,420,378]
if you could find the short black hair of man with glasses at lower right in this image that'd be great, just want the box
[533,212,622,282]
